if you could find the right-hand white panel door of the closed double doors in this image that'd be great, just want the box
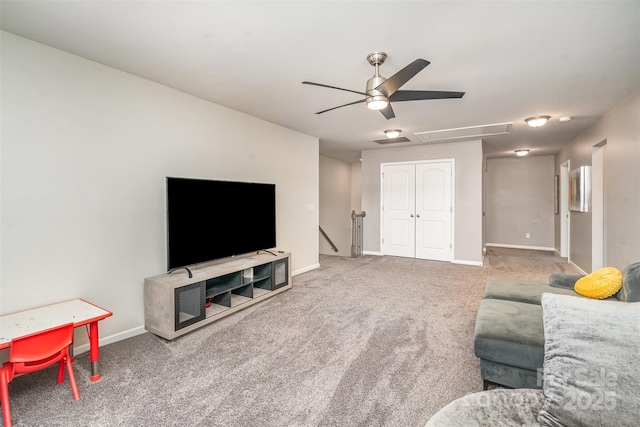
[416,162,452,261]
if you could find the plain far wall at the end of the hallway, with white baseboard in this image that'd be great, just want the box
[485,156,555,250]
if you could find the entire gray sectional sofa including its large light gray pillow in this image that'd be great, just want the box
[425,262,640,427]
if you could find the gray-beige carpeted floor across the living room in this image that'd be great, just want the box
[3,248,577,427]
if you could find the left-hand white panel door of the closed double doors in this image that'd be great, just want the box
[382,164,416,258]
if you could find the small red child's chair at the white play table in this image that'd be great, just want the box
[0,323,80,427]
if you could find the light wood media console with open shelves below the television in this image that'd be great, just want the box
[144,252,291,340]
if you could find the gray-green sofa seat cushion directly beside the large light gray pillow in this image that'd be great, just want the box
[473,299,544,371]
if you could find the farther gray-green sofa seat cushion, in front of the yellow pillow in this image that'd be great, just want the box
[483,276,577,305]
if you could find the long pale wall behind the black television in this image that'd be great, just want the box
[0,32,319,348]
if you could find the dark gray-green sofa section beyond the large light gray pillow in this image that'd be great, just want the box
[473,263,640,390]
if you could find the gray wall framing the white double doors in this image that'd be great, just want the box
[361,140,483,264]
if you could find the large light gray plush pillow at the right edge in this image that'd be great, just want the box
[538,293,640,427]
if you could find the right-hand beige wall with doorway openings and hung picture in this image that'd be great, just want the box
[555,91,640,272]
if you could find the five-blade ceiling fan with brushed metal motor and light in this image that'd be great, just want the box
[302,52,464,120]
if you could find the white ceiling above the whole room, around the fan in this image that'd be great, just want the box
[0,0,640,162]
